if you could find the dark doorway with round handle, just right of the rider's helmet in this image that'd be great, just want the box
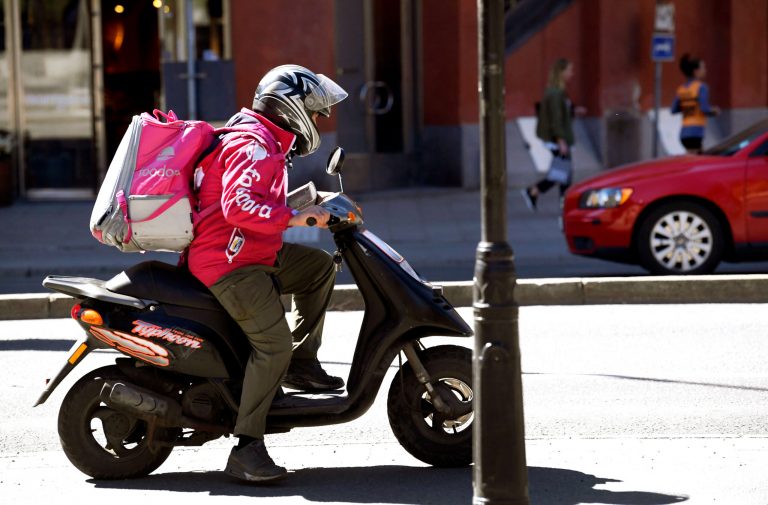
[335,0,421,190]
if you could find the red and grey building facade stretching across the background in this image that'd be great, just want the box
[0,0,768,203]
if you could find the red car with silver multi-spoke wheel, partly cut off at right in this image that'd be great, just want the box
[563,120,768,274]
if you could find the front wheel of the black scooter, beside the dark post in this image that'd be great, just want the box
[387,345,475,467]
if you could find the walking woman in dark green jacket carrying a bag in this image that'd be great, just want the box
[521,58,574,211]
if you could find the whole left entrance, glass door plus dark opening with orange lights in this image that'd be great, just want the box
[0,0,163,199]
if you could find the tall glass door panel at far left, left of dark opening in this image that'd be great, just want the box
[10,0,95,198]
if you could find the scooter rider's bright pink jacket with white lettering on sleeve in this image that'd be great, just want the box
[187,108,295,287]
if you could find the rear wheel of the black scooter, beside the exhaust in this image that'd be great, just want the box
[59,365,176,479]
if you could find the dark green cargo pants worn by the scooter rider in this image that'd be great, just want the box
[211,243,336,438]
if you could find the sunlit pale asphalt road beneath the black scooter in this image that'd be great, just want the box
[0,305,768,505]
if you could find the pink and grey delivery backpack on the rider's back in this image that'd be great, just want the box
[90,109,222,252]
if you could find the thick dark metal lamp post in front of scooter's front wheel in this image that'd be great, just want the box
[473,0,529,505]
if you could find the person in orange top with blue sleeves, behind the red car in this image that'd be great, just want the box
[672,53,720,154]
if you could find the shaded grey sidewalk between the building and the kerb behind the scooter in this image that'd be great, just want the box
[0,188,568,294]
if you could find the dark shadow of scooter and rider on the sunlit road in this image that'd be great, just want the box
[89,466,687,505]
